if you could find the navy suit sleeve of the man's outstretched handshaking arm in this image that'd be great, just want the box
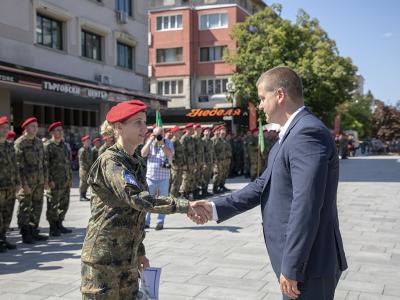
[214,171,266,223]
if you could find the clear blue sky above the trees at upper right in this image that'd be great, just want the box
[264,0,400,105]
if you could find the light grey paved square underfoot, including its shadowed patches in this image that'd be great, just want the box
[0,157,400,300]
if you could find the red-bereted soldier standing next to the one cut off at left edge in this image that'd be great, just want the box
[14,117,48,244]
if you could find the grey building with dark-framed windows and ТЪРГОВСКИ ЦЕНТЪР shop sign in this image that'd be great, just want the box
[0,0,167,139]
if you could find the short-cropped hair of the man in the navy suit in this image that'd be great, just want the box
[257,66,303,102]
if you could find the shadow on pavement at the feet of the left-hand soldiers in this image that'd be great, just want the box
[0,228,86,275]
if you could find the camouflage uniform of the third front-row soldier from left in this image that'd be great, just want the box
[44,139,72,225]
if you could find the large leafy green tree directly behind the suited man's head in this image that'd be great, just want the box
[226,5,357,127]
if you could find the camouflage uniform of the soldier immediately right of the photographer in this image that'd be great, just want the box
[170,136,185,197]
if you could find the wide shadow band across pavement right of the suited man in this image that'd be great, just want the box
[339,157,400,182]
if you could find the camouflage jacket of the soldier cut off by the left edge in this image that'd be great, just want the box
[0,141,21,190]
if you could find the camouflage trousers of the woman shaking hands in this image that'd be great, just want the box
[81,262,139,300]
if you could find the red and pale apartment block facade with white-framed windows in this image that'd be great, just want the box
[149,0,265,131]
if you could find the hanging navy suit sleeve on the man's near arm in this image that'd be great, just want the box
[281,128,332,281]
